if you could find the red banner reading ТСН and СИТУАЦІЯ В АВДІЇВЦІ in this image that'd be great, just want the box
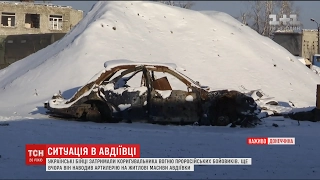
[26,144,140,165]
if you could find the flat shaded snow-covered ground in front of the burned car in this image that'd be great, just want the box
[0,117,320,179]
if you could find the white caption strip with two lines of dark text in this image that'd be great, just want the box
[46,158,252,171]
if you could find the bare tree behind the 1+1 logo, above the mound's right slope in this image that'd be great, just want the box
[237,1,299,37]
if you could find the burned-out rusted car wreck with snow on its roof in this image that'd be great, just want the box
[44,60,261,127]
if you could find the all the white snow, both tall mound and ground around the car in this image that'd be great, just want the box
[0,1,320,179]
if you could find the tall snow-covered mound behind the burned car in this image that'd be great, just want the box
[0,1,320,114]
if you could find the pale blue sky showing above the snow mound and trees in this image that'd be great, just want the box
[51,1,320,29]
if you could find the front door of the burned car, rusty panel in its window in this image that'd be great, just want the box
[150,72,200,124]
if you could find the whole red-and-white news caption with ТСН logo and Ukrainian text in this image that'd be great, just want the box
[26,144,252,171]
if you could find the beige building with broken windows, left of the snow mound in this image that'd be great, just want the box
[0,2,83,35]
